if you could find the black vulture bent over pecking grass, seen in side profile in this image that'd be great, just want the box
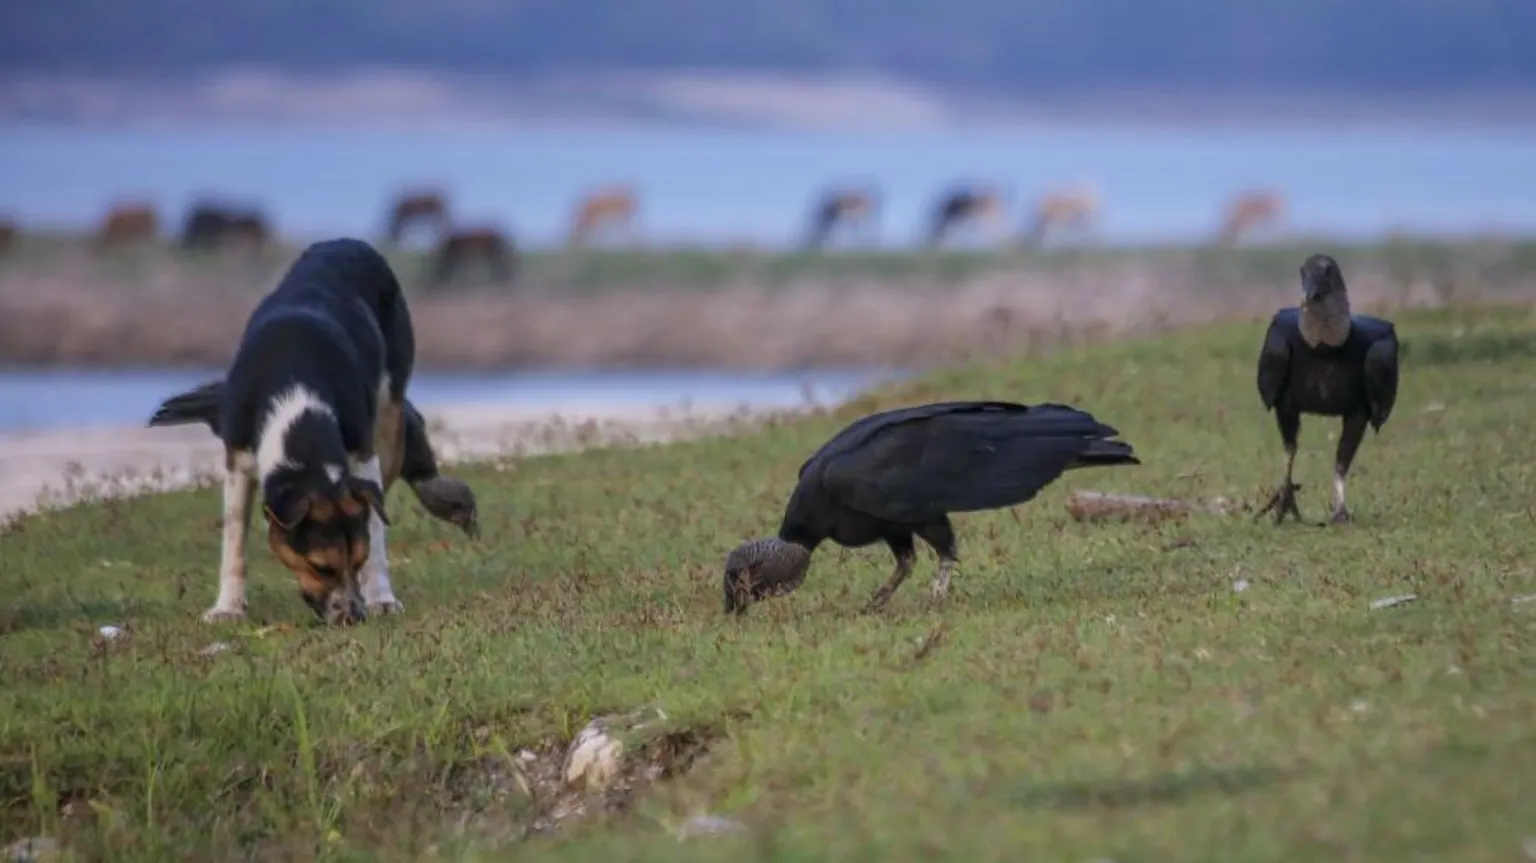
[725,401,1141,614]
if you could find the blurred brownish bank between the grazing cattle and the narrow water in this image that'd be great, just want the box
[0,236,1536,372]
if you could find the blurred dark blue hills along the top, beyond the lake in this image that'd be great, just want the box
[9,0,1536,124]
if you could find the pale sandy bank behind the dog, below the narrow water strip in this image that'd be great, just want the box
[0,404,786,524]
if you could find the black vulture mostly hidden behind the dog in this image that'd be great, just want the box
[149,381,479,537]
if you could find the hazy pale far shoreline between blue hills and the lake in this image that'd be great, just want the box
[9,68,1536,131]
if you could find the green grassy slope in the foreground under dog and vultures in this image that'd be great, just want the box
[0,309,1536,863]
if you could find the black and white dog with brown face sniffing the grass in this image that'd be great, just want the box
[175,238,416,623]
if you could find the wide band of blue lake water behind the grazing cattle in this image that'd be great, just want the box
[0,124,1536,246]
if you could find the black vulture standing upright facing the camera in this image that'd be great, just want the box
[1255,255,1398,524]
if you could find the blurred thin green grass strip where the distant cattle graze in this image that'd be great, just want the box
[9,235,1536,293]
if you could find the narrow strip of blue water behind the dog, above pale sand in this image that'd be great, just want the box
[0,369,897,433]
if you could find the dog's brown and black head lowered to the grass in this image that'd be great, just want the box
[263,476,389,625]
